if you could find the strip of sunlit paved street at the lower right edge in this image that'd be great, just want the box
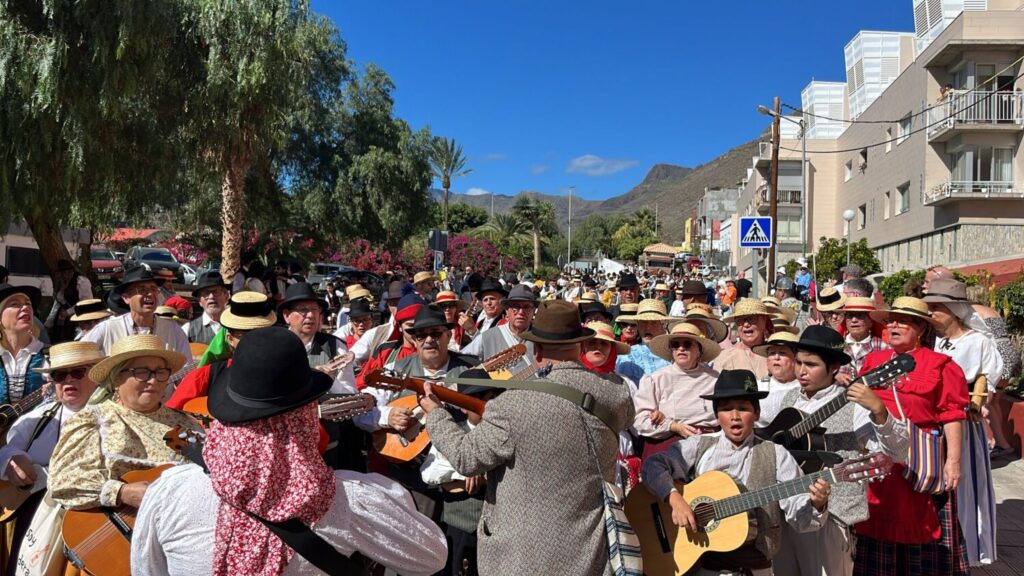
[974,456,1024,576]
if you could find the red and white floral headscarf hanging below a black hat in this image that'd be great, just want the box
[203,402,337,576]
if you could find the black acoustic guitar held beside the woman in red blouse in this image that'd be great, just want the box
[754,354,916,474]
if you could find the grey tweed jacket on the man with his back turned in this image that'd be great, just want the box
[427,362,634,576]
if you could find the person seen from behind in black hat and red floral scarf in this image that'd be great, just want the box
[131,327,445,576]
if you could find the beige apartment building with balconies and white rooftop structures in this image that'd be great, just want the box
[732,0,1024,286]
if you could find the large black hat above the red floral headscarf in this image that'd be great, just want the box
[209,326,333,423]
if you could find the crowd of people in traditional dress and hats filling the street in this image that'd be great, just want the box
[0,253,1020,576]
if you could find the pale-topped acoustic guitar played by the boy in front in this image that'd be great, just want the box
[625,453,893,576]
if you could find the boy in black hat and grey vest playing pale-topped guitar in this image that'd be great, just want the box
[643,370,830,576]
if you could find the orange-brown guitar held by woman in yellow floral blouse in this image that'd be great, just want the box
[60,427,204,576]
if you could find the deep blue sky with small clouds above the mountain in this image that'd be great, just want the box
[312,0,913,199]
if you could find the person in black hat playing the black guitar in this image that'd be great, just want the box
[773,326,909,576]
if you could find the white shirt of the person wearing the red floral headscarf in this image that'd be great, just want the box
[131,464,447,576]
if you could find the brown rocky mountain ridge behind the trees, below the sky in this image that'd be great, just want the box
[442,139,759,237]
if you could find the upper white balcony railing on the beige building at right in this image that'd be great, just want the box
[928,90,1024,138]
